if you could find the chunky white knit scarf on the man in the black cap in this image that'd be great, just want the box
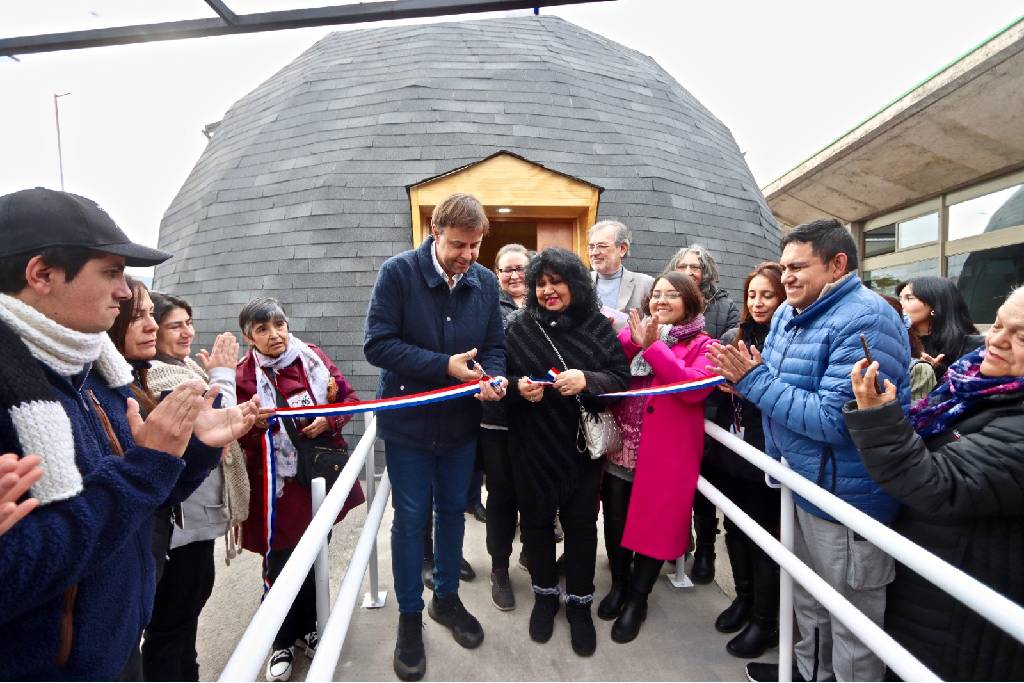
[0,294,132,505]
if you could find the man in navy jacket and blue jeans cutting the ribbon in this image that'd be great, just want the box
[362,194,507,681]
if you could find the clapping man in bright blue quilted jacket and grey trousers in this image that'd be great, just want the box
[712,220,910,681]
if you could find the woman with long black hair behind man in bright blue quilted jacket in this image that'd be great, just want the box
[896,275,984,381]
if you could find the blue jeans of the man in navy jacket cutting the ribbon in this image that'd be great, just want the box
[384,441,476,614]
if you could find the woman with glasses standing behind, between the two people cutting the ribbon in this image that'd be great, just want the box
[477,244,530,611]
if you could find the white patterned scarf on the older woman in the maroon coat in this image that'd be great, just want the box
[253,335,331,498]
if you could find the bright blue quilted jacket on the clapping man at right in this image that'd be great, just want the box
[736,274,910,522]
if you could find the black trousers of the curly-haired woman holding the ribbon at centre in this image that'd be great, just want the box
[514,456,603,597]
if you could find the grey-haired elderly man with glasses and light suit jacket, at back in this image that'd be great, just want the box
[587,220,654,330]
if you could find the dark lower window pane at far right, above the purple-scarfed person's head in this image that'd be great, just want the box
[946,245,1024,325]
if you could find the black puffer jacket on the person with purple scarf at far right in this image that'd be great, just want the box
[844,400,1024,681]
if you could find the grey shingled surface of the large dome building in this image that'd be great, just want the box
[156,16,779,397]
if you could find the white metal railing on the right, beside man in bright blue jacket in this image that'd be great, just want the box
[697,420,1024,683]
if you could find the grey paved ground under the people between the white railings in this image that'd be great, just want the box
[198,489,774,681]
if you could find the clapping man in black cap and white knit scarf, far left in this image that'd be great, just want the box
[0,188,257,680]
